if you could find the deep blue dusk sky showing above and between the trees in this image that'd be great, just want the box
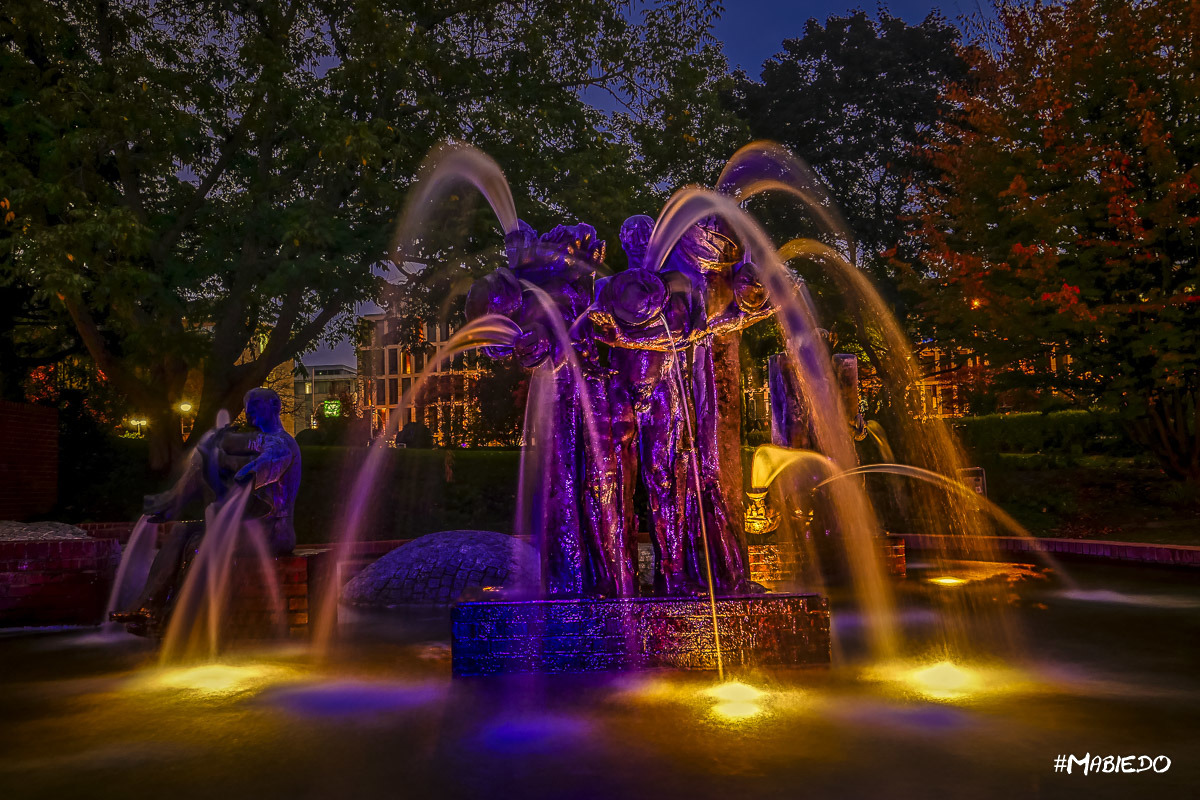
[302,0,974,367]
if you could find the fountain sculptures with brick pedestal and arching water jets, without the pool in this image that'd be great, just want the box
[87,143,1041,676]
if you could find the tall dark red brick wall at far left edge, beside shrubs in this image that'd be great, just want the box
[0,401,59,521]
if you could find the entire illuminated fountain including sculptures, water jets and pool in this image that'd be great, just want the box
[0,144,1200,798]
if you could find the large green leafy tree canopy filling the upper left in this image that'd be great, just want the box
[0,0,713,468]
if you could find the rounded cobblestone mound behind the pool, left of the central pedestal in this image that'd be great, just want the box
[342,530,539,608]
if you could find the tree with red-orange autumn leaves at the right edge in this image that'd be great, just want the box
[908,0,1200,481]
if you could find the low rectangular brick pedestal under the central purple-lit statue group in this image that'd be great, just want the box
[452,595,830,675]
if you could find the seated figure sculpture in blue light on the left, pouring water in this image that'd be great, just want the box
[112,389,300,636]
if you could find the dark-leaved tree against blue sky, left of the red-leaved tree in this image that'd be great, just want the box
[731,11,965,281]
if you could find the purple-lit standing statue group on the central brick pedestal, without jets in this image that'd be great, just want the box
[467,215,770,596]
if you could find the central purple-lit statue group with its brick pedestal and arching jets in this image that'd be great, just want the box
[338,144,945,674]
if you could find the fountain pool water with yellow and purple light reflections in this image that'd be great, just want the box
[0,563,1200,799]
